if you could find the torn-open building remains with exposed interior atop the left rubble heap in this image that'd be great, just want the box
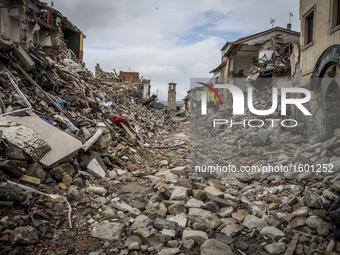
[0,0,86,61]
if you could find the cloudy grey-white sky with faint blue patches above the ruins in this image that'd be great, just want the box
[51,0,300,101]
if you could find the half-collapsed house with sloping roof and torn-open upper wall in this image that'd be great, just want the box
[210,27,300,92]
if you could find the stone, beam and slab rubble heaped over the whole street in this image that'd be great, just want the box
[0,2,340,255]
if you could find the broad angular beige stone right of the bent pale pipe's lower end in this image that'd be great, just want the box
[91,222,125,242]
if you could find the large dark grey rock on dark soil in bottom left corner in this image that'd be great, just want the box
[10,226,39,245]
